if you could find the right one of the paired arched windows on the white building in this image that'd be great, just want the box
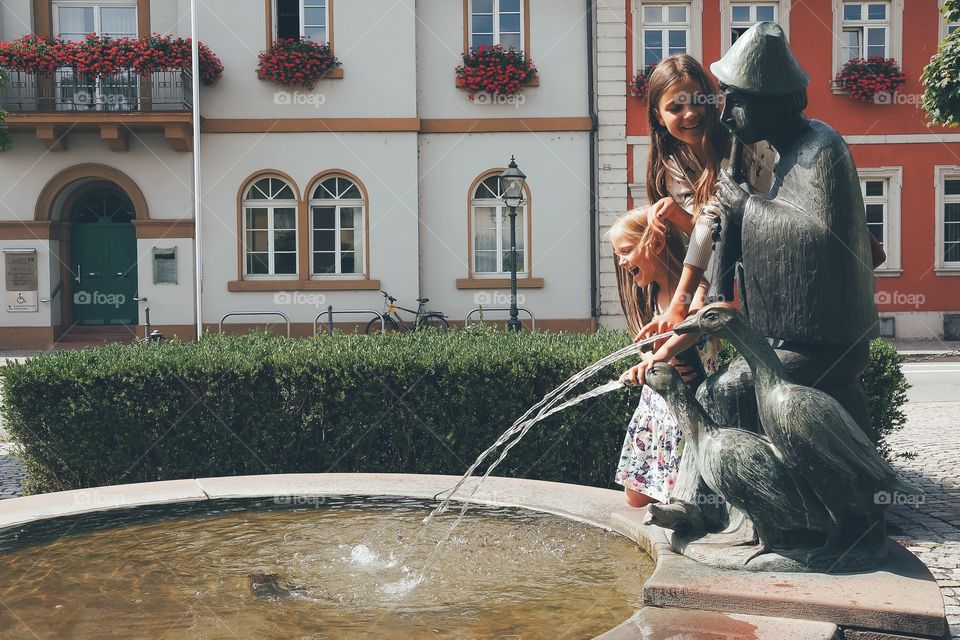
[310,176,365,276]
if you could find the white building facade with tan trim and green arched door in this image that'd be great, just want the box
[0,0,604,348]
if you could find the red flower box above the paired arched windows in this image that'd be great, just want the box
[257,36,342,89]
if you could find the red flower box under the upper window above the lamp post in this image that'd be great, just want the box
[456,45,539,100]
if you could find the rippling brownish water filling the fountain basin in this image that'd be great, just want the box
[0,498,652,640]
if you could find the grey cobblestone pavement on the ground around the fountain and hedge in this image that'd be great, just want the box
[0,402,960,638]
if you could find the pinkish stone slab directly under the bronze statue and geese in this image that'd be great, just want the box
[611,512,947,637]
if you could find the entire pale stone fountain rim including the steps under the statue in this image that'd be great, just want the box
[0,474,947,640]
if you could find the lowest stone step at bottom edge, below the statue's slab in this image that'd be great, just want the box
[596,607,843,640]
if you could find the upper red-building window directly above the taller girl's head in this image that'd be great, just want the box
[633,0,703,70]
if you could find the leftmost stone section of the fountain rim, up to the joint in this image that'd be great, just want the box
[0,480,207,529]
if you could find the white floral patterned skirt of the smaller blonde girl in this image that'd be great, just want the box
[616,336,720,502]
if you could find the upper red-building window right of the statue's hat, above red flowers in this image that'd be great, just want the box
[833,0,904,84]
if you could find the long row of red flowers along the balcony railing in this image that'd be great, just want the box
[0,34,223,86]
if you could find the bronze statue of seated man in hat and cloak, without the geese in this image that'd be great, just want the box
[650,22,884,560]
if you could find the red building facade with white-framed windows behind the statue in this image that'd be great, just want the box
[626,0,960,339]
